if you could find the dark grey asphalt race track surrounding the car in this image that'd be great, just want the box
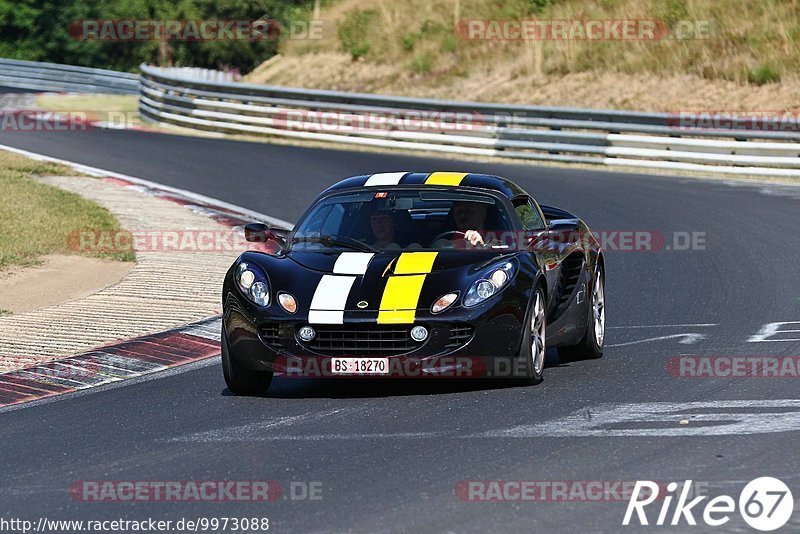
[0,124,800,532]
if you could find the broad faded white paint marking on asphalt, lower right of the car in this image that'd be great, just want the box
[482,399,800,438]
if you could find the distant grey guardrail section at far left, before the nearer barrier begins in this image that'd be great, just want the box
[0,58,139,94]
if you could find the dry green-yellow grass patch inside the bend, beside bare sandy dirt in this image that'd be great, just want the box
[0,152,134,271]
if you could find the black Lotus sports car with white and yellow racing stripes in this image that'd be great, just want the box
[222,172,605,394]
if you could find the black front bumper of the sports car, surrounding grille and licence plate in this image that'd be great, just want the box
[223,287,527,376]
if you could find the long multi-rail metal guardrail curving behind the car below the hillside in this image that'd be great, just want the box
[139,65,800,176]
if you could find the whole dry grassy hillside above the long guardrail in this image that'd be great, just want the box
[247,0,800,111]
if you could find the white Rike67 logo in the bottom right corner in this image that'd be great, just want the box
[622,477,794,532]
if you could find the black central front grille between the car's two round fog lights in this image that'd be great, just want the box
[306,324,424,356]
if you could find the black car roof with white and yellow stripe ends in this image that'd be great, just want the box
[323,172,528,199]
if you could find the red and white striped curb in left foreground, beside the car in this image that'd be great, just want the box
[0,317,222,408]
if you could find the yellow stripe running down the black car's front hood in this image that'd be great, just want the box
[378,252,438,324]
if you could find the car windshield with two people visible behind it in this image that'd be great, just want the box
[290,190,513,252]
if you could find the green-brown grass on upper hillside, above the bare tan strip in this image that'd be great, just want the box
[292,0,800,85]
